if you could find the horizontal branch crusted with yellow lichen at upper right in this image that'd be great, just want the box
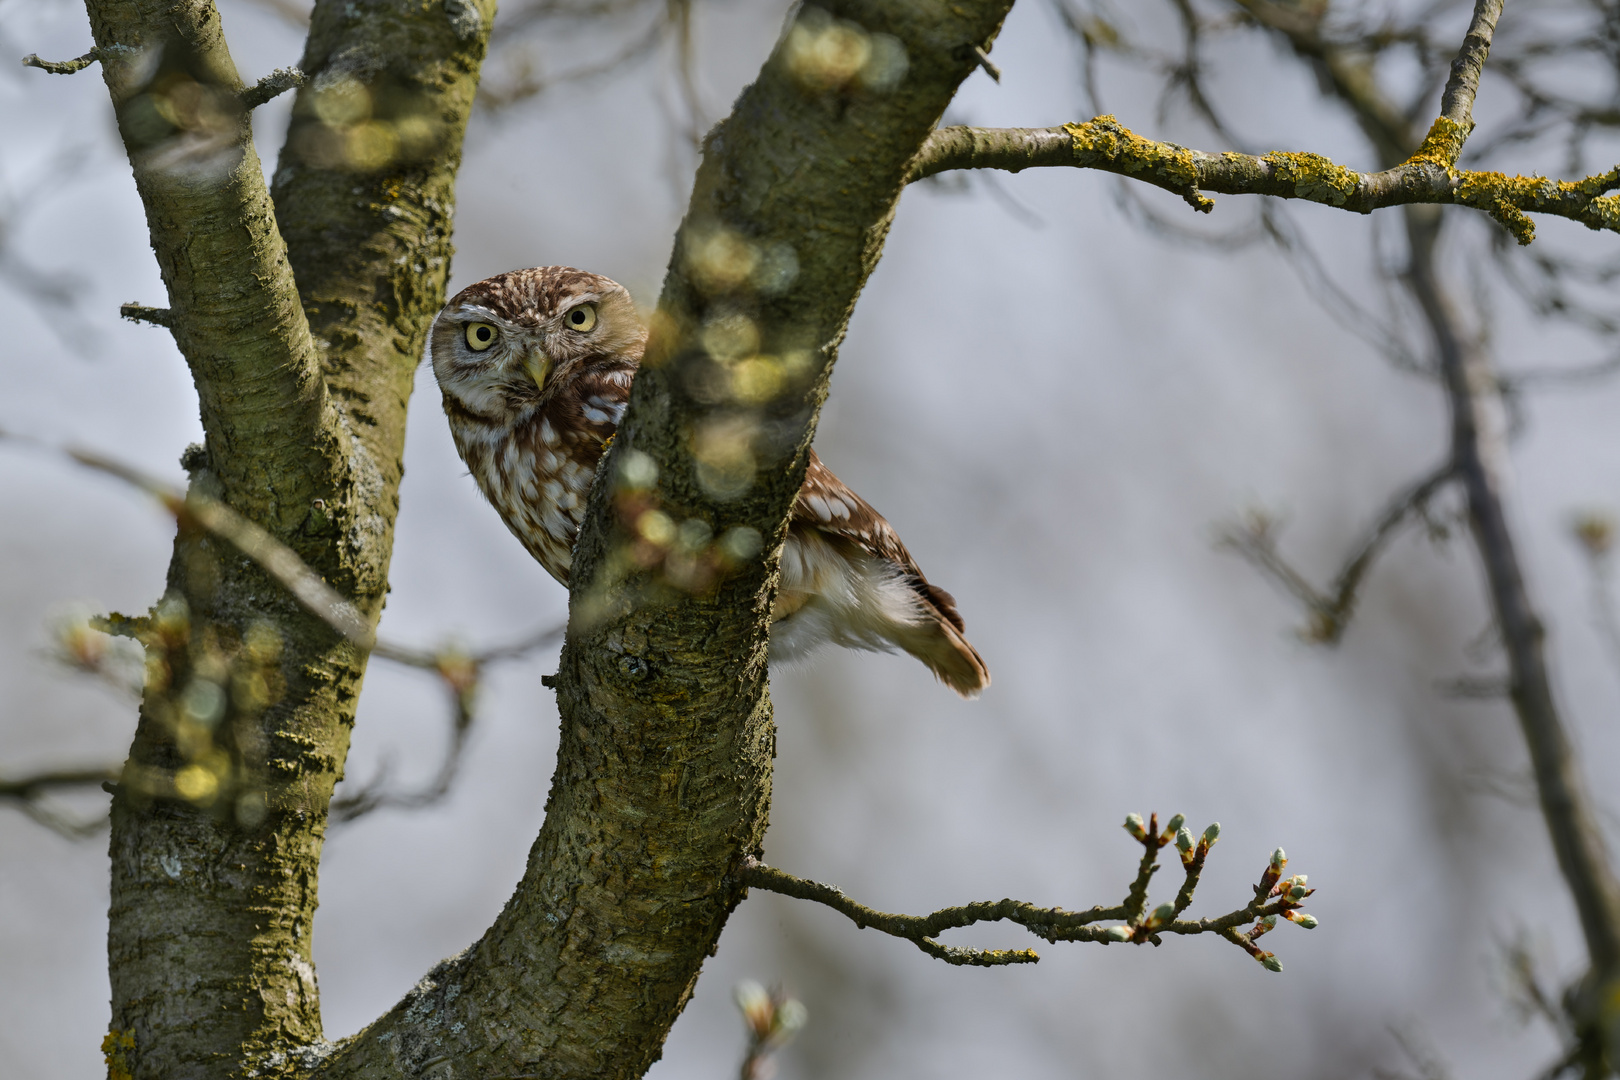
[907,117,1620,244]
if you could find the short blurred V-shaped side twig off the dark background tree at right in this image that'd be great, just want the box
[1218,461,1456,644]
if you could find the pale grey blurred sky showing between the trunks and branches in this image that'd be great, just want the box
[0,0,1620,1080]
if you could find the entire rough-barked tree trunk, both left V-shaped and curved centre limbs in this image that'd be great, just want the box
[87,0,1011,1080]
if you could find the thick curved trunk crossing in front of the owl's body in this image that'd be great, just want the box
[306,0,1009,1077]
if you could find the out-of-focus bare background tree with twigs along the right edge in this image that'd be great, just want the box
[1058,0,1620,1075]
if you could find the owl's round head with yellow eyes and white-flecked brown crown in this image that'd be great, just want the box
[429,266,646,421]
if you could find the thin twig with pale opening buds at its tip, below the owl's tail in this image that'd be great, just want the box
[740,814,1317,972]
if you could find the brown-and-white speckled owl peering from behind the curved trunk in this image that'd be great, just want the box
[429,266,990,698]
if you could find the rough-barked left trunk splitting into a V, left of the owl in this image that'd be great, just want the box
[87,0,494,1080]
